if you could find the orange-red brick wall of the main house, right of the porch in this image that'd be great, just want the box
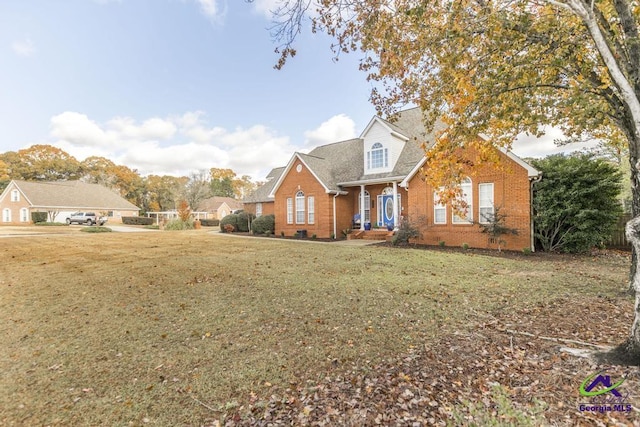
[408,150,531,250]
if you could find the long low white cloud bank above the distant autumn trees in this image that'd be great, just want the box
[50,111,296,180]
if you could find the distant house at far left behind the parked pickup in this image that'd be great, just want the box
[0,180,140,225]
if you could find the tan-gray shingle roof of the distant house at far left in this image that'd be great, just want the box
[13,180,140,210]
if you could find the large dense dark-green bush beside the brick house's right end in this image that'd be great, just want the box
[533,154,622,252]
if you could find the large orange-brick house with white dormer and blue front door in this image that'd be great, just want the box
[245,108,540,250]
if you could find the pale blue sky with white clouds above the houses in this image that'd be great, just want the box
[0,0,592,180]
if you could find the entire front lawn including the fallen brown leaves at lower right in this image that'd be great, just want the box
[0,231,640,425]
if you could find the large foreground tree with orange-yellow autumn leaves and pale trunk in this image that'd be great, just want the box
[258,0,640,352]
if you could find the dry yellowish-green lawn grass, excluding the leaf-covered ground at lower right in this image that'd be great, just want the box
[0,231,627,425]
